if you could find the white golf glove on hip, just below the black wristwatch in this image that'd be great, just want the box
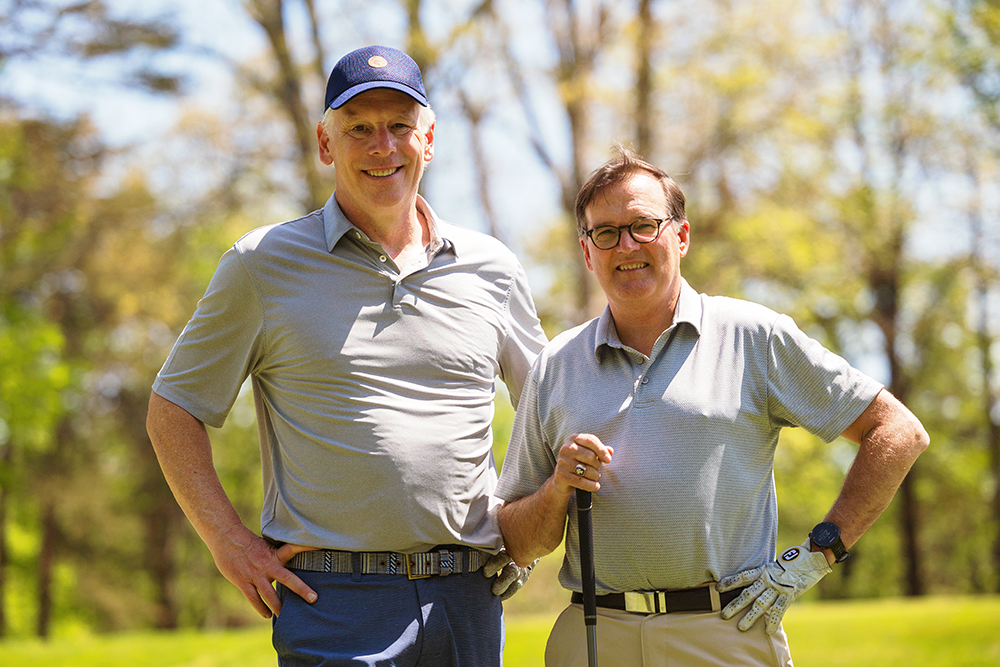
[715,539,833,635]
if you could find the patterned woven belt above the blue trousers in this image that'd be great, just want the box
[285,547,490,579]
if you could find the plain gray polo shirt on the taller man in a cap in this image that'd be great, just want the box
[153,197,545,552]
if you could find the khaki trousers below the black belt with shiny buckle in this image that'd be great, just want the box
[545,604,792,667]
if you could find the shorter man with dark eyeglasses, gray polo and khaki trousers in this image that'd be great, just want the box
[497,148,928,667]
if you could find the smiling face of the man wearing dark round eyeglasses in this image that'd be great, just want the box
[580,172,690,318]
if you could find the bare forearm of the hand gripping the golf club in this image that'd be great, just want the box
[497,479,572,567]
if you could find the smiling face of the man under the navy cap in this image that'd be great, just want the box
[316,88,434,224]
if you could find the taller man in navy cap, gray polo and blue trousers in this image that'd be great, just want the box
[147,46,545,667]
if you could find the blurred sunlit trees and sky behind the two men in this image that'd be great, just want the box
[0,0,1000,636]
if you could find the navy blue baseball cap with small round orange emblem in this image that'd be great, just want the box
[324,46,427,111]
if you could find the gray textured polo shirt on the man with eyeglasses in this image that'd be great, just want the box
[497,282,882,594]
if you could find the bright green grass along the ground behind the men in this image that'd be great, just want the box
[0,596,1000,667]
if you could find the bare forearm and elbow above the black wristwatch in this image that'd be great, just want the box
[826,391,929,547]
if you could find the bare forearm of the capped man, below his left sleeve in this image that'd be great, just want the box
[146,392,243,553]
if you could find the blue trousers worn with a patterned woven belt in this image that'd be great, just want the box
[272,570,504,667]
